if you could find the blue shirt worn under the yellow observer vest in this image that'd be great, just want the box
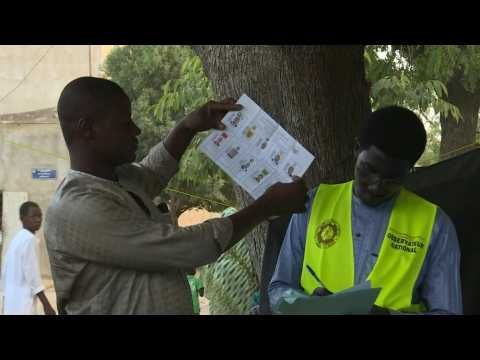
[268,189,463,315]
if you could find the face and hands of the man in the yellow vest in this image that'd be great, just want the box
[313,145,413,315]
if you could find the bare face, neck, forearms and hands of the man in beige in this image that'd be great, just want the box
[68,93,308,268]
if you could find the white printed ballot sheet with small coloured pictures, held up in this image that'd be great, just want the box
[199,94,314,199]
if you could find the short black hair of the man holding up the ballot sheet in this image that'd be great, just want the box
[57,76,128,145]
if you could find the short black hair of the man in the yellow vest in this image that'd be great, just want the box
[359,106,427,166]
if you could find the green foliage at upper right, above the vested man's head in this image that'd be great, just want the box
[365,45,480,165]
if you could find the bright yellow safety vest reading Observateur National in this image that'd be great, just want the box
[300,181,437,312]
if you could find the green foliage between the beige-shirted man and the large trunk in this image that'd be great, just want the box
[104,45,235,215]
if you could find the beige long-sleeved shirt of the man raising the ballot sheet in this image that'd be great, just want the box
[44,143,233,314]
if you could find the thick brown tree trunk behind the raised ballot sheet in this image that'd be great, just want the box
[193,45,370,278]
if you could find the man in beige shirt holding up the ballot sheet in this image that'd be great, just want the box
[45,77,307,314]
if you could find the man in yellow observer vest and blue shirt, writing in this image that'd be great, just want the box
[269,106,462,314]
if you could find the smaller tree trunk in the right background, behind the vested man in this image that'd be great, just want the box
[440,72,480,160]
